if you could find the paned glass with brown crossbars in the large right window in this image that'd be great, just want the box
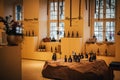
[94,0,116,41]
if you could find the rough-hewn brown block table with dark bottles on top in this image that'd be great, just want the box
[42,60,113,80]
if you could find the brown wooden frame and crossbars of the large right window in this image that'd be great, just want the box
[90,0,117,43]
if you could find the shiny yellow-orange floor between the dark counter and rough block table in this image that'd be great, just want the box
[22,59,50,80]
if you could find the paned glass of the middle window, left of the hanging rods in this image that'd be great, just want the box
[49,1,64,39]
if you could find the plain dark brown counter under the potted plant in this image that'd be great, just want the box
[0,46,22,80]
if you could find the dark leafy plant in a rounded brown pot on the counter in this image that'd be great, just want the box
[0,15,23,45]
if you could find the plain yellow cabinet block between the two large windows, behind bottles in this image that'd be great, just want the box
[61,38,82,57]
